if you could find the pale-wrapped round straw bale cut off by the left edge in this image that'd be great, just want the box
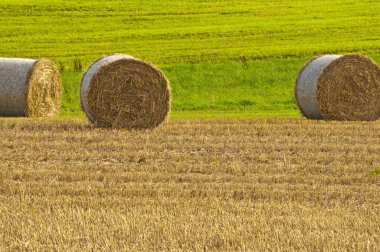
[0,58,62,117]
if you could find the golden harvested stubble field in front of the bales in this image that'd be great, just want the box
[0,119,380,251]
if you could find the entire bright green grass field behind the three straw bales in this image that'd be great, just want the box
[0,0,380,116]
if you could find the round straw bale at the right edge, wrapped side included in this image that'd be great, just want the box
[295,54,380,121]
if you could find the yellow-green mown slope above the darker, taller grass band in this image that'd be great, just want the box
[0,0,380,67]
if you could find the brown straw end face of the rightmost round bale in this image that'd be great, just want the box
[317,54,380,121]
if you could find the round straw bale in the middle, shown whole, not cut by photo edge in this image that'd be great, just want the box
[80,54,170,129]
